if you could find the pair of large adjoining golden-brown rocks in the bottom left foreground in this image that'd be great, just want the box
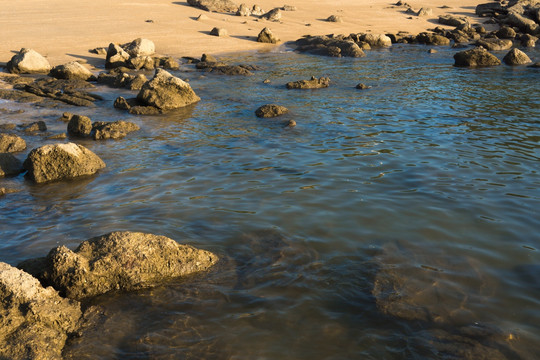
[0,232,218,360]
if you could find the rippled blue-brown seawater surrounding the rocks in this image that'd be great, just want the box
[0,45,540,359]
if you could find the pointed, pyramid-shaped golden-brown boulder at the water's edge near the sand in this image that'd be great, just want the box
[137,69,200,110]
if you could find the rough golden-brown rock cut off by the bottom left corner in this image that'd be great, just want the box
[0,263,81,360]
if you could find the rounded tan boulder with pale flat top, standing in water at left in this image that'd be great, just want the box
[23,143,105,183]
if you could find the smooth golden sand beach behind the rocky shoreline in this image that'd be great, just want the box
[0,0,488,66]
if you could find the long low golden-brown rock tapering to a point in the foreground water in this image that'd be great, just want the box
[20,232,218,299]
